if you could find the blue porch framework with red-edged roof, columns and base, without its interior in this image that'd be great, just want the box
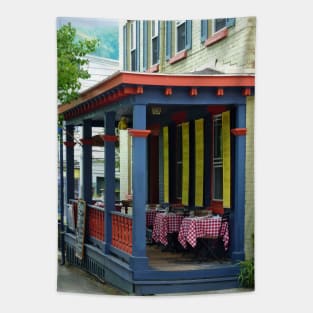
[59,73,254,295]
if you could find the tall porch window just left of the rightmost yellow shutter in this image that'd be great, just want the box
[213,114,223,200]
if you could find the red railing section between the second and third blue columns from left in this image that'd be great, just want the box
[87,204,104,241]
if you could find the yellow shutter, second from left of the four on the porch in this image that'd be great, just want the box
[182,122,189,205]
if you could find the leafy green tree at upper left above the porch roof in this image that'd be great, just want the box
[57,23,99,103]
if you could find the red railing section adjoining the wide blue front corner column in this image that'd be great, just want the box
[111,213,133,254]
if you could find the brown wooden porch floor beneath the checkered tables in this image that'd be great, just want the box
[146,244,231,271]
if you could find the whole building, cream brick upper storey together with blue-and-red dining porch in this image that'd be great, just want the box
[58,18,255,295]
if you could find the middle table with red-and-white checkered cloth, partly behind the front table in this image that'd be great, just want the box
[152,213,184,246]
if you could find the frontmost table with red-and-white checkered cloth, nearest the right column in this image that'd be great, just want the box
[178,216,229,250]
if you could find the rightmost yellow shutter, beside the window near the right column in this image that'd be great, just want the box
[222,111,231,208]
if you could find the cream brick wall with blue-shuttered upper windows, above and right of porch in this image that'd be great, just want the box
[119,17,256,259]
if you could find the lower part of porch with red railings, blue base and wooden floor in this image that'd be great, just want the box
[65,200,239,295]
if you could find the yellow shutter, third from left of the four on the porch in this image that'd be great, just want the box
[195,118,204,206]
